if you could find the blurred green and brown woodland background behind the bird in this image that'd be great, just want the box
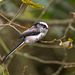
[0,0,75,75]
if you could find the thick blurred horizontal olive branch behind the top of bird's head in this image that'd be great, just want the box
[17,17,74,26]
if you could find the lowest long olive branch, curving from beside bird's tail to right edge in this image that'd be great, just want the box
[16,52,75,65]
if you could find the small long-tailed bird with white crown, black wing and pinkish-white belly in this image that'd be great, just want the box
[2,22,49,63]
